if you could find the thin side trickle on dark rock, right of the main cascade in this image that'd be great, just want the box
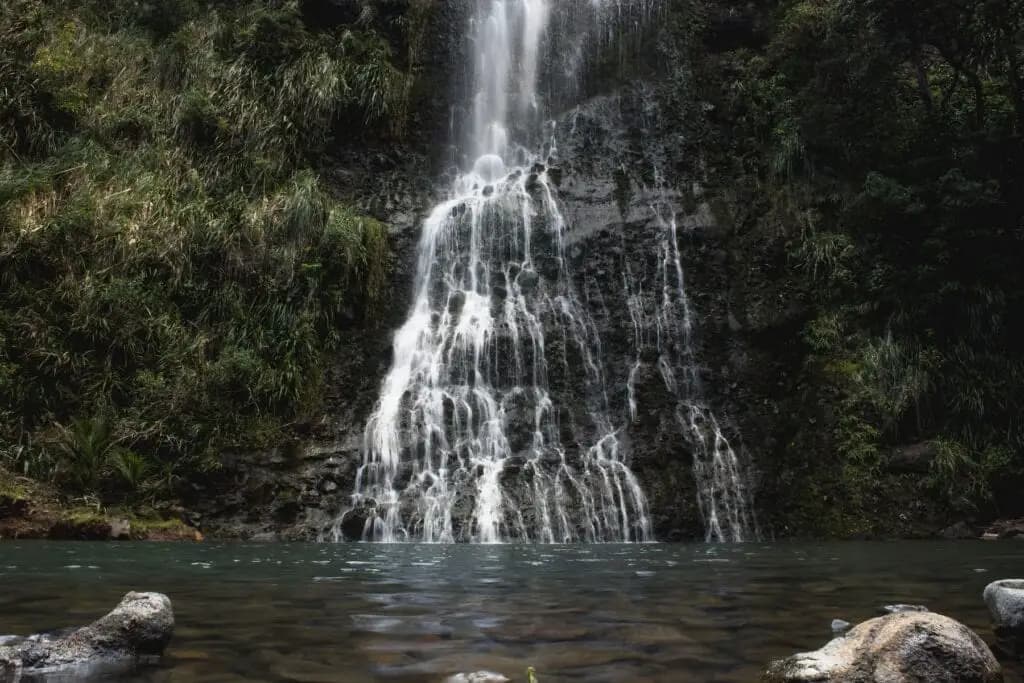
[623,178,758,542]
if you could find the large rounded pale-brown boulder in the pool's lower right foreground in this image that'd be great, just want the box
[763,612,1002,683]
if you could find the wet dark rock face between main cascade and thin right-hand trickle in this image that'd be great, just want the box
[558,90,745,541]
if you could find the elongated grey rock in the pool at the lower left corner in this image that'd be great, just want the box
[0,593,174,683]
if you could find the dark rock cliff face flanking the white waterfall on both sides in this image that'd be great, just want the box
[189,3,966,540]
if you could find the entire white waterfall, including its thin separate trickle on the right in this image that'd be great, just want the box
[333,0,756,543]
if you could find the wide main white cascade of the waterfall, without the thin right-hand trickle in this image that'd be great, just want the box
[339,0,651,543]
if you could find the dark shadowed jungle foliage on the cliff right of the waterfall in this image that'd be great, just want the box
[679,0,1024,535]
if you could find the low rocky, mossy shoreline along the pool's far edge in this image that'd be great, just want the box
[0,458,1024,542]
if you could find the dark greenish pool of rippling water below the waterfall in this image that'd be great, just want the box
[0,542,1024,683]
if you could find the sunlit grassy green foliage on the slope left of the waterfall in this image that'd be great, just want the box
[0,0,431,502]
